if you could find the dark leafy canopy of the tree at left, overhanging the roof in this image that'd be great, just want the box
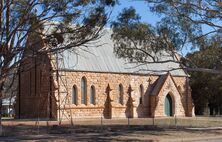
[0,0,115,127]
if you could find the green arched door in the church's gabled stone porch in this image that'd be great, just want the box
[164,94,173,116]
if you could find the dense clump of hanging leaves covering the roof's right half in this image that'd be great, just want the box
[111,7,179,63]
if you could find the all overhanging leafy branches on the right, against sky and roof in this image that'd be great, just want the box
[112,0,222,74]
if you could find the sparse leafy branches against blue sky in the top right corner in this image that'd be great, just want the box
[144,0,222,48]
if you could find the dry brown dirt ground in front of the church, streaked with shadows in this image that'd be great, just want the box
[0,118,222,142]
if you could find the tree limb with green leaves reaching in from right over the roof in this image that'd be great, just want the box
[112,3,222,74]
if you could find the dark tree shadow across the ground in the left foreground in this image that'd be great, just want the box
[0,125,164,142]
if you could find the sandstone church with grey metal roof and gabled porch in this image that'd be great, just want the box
[16,31,193,120]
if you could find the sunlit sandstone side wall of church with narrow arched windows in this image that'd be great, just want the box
[55,71,192,119]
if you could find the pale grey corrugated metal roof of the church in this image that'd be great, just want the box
[57,29,186,76]
